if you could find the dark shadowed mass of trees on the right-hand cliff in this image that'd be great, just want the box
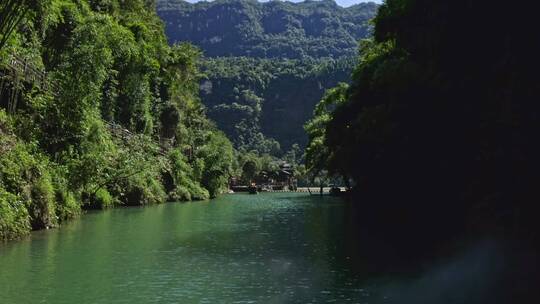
[306,0,540,233]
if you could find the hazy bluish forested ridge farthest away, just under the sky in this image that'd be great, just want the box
[158,0,377,59]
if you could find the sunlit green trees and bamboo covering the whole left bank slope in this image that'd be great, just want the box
[0,0,234,239]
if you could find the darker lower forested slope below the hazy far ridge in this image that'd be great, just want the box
[201,57,355,151]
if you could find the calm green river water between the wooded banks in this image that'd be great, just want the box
[0,193,524,304]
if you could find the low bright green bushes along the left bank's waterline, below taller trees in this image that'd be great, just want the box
[0,105,232,242]
